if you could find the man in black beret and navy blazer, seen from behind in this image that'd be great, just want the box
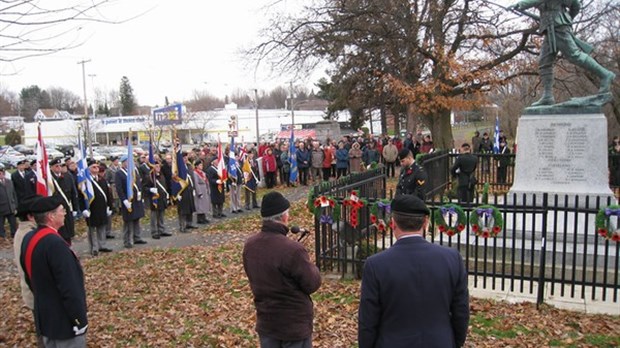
[358,195,469,348]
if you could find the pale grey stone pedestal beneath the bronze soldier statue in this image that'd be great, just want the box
[509,113,616,207]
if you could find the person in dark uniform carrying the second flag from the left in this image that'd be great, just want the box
[78,159,112,256]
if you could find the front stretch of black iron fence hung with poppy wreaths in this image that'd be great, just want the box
[315,188,620,303]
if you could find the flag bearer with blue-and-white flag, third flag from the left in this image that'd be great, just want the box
[114,135,146,248]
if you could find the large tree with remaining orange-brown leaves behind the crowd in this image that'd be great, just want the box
[247,0,612,148]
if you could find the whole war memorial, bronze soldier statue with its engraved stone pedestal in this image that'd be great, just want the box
[509,0,615,207]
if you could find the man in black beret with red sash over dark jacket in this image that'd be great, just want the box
[20,195,88,347]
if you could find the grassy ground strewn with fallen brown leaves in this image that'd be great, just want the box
[0,184,620,348]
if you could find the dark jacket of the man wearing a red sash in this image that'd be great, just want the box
[20,227,88,340]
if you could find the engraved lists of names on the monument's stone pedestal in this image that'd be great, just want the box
[533,122,588,185]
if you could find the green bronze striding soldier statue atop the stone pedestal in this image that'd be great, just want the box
[508,0,616,106]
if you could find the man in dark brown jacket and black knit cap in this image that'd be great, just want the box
[243,191,321,348]
